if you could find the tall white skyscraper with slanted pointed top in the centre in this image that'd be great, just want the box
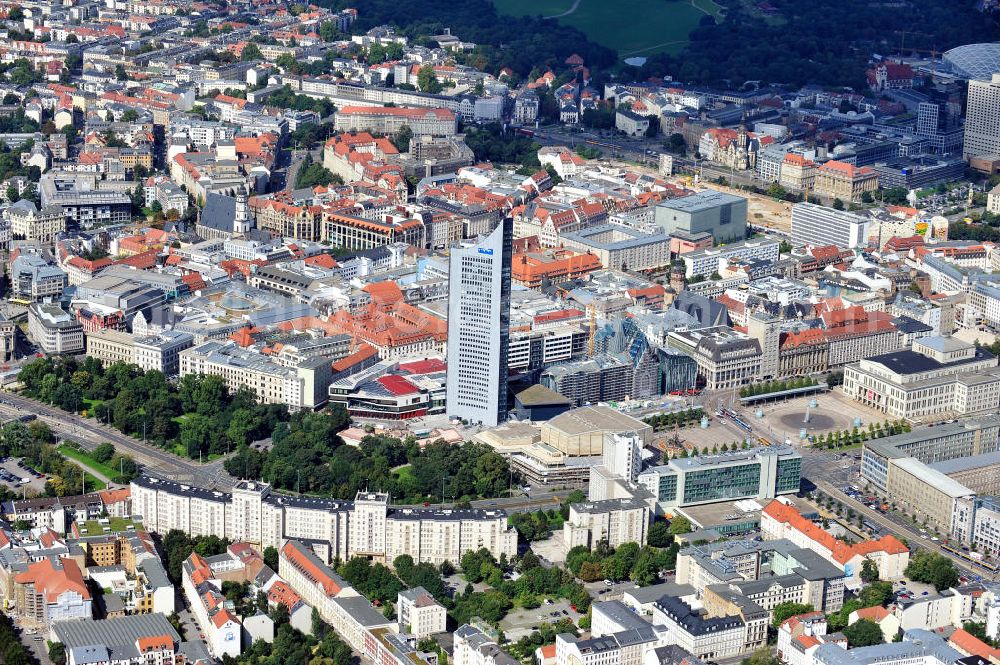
[447,217,514,427]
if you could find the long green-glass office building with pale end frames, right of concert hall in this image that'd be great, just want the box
[637,446,802,512]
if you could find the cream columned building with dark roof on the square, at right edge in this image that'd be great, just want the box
[843,337,1000,420]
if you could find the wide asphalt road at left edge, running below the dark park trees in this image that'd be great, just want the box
[0,393,235,489]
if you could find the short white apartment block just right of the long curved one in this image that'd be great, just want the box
[563,499,651,550]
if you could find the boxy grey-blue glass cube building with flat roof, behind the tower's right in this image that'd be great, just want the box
[653,190,747,243]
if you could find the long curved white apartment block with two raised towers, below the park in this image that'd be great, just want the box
[131,476,517,565]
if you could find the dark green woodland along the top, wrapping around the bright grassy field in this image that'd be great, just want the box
[320,0,1000,88]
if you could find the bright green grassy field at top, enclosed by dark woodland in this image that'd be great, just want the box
[493,0,721,58]
